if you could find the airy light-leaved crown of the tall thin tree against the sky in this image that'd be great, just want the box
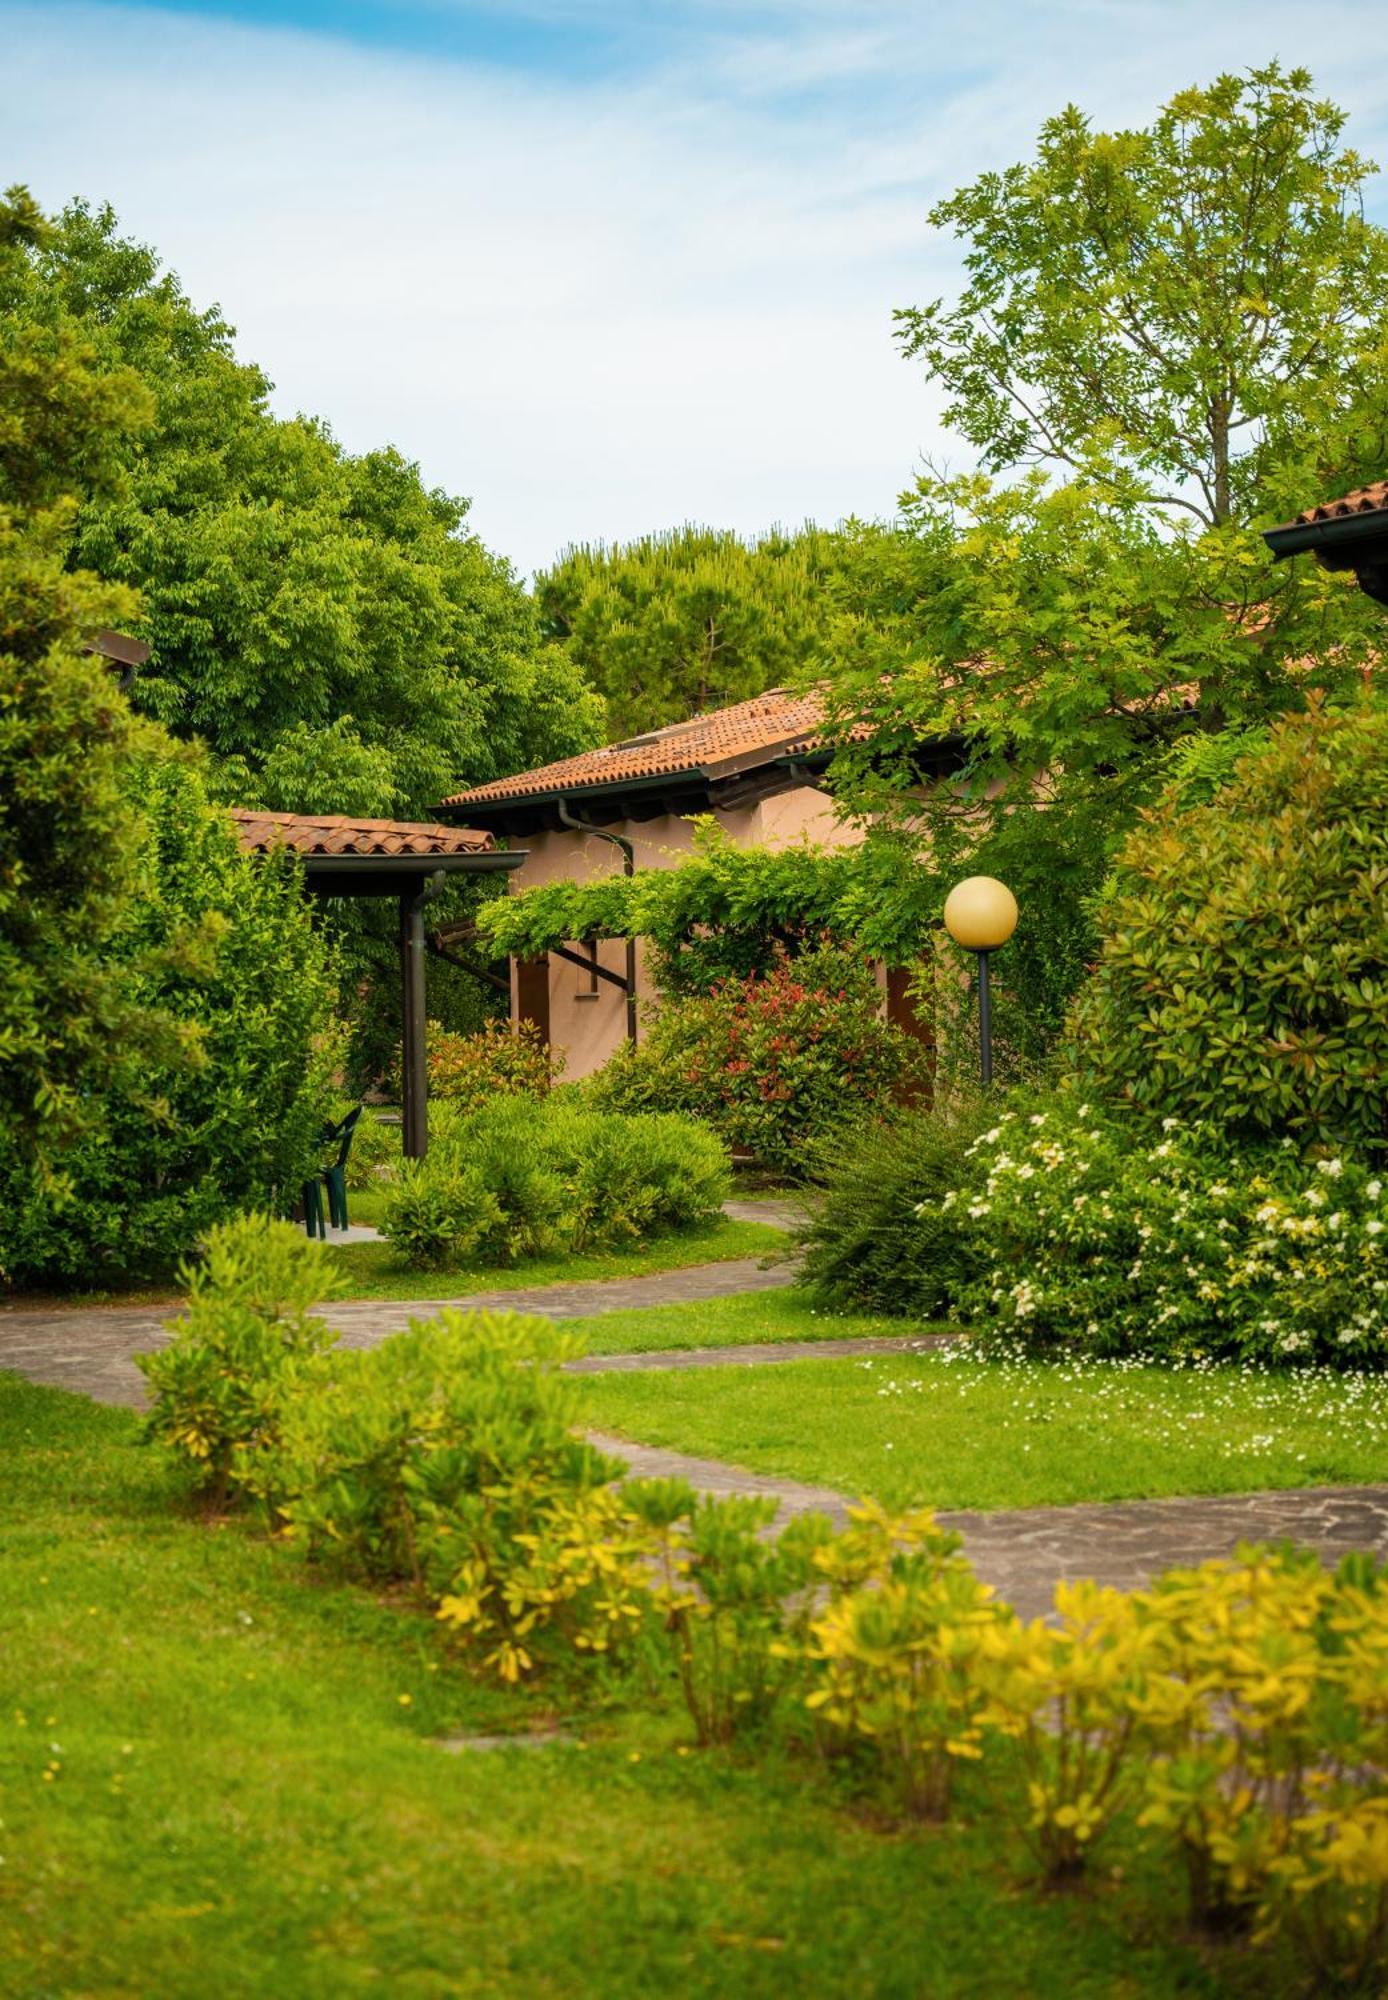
[898,62,1388,526]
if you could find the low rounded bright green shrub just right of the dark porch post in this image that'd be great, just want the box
[384,1098,730,1268]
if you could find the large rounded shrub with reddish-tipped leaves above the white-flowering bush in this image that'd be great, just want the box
[1076,700,1388,1154]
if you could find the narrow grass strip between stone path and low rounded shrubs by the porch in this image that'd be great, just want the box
[328,1202,786,1298]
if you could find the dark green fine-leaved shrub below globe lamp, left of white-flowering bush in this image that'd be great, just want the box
[800,1100,996,1320]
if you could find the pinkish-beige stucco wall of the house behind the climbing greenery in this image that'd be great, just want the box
[508,786,858,1082]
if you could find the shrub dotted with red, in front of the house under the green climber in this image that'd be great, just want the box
[588,946,928,1176]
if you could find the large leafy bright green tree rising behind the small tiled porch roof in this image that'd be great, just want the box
[0,202,600,816]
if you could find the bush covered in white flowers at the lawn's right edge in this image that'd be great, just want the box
[948,1100,1388,1368]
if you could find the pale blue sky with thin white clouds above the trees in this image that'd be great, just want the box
[0,0,1388,574]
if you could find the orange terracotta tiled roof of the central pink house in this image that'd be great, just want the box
[444,688,848,806]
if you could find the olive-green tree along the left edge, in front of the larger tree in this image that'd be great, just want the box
[0,188,158,1178]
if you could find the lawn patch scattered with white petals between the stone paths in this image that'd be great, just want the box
[588,1294,1388,1508]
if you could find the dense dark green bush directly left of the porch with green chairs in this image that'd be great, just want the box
[0,732,336,1284]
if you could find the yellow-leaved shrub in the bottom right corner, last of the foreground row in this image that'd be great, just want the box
[1136,1548,1388,1984]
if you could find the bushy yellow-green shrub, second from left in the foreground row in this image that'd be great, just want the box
[256,1310,646,1680]
